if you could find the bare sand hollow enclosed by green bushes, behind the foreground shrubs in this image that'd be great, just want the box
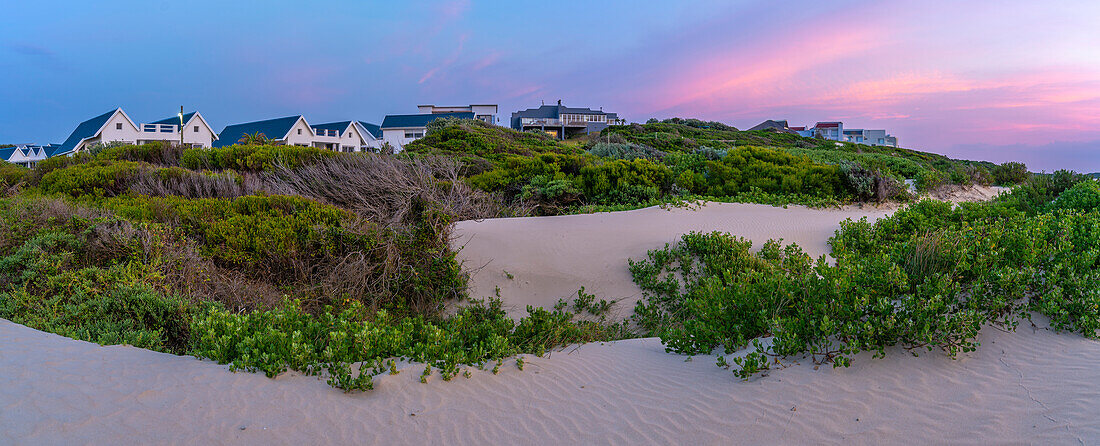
[454,203,890,317]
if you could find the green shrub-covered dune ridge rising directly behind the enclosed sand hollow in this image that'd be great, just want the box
[406,119,1027,215]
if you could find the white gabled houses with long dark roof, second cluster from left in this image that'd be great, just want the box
[215,115,382,152]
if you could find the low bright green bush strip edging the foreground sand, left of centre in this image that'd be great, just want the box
[190,301,625,390]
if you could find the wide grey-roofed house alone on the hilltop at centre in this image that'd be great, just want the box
[512,100,622,140]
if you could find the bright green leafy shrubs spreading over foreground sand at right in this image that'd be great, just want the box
[630,172,1100,377]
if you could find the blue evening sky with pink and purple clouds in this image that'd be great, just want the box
[0,0,1100,172]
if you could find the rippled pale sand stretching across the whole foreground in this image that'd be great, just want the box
[0,319,1100,445]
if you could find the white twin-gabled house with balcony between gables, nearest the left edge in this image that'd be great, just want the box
[50,108,217,156]
